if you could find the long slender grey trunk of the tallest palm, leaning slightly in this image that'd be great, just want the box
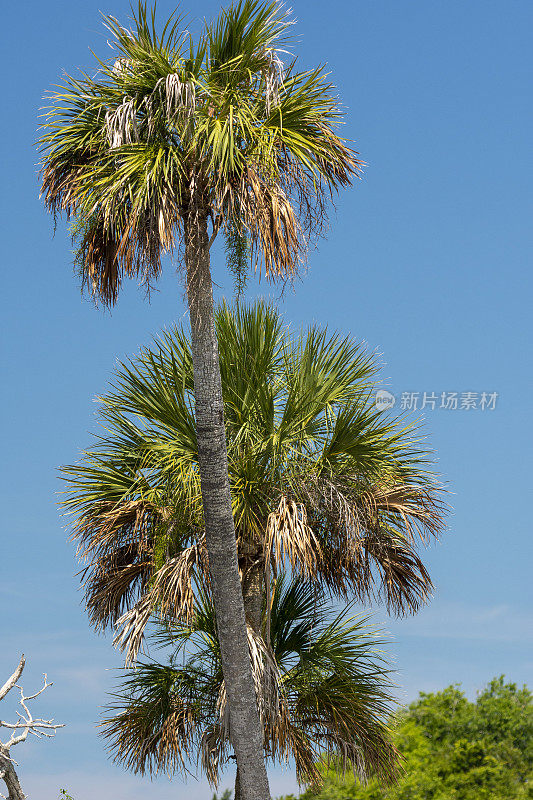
[185,209,270,800]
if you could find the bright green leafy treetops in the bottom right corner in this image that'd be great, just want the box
[284,677,533,800]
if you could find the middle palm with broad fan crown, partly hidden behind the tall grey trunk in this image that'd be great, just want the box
[63,303,444,663]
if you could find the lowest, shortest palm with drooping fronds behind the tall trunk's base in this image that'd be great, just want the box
[103,573,397,800]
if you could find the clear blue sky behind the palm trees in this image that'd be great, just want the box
[0,0,533,800]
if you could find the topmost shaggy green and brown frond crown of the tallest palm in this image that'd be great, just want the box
[40,0,361,303]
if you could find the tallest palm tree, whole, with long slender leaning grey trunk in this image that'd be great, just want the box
[41,0,361,800]
